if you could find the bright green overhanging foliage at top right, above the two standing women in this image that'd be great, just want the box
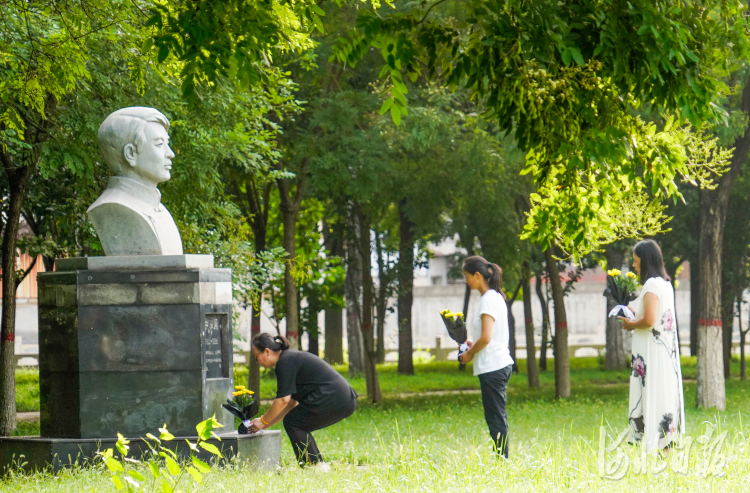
[335,0,749,258]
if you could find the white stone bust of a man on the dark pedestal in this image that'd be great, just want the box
[87,106,182,255]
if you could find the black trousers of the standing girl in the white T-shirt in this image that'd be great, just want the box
[479,365,513,459]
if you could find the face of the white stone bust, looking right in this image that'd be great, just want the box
[125,122,174,186]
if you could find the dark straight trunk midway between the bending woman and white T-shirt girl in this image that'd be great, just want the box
[398,201,414,375]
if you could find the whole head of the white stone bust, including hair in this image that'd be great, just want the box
[99,106,174,187]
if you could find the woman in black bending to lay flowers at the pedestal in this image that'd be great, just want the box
[250,333,357,465]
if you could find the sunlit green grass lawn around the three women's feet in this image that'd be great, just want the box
[5,358,750,492]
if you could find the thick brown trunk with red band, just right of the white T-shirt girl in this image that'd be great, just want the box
[544,245,570,399]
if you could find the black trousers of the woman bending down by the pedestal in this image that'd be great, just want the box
[284,392,357,466]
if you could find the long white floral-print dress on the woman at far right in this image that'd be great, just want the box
[628,277,685,452]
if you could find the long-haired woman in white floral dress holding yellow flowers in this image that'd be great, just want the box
[620,240,685,452]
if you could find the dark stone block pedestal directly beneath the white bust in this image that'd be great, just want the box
[38,255,234,438]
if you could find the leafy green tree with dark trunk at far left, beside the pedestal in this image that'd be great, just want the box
[0,0,150,436]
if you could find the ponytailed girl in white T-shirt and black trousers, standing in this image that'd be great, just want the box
[461,256,513,459]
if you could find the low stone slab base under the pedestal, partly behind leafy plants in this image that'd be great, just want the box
[0,430,281,476]
